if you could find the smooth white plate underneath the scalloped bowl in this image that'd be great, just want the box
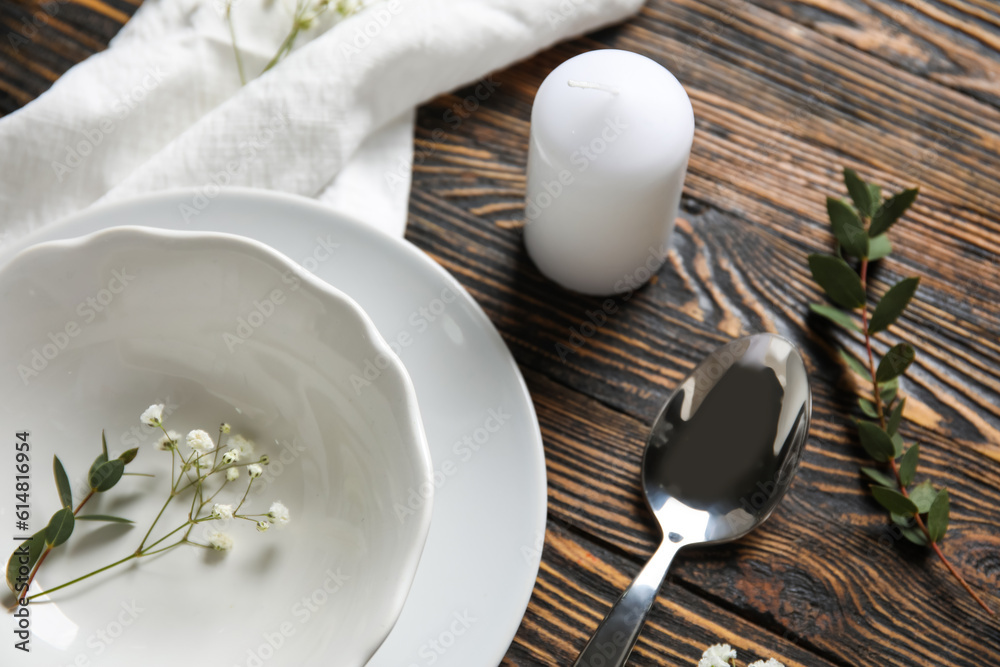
[0,190,546,667]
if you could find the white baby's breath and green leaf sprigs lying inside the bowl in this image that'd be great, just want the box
[7,405,290,601]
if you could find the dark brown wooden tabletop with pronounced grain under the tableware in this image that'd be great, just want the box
[0,0,1000,667]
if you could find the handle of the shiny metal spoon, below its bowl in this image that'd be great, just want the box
[573,540,682,667]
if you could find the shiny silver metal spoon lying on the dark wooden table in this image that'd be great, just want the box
[573,334,812,667]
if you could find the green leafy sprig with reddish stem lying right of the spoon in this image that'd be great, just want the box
[809,169,994,616]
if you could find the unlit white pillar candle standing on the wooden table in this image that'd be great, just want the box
[524,49,694,295]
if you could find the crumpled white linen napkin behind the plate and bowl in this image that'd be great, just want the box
[0,0,642,244]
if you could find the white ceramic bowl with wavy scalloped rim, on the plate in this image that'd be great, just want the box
[0,227,433,667]
